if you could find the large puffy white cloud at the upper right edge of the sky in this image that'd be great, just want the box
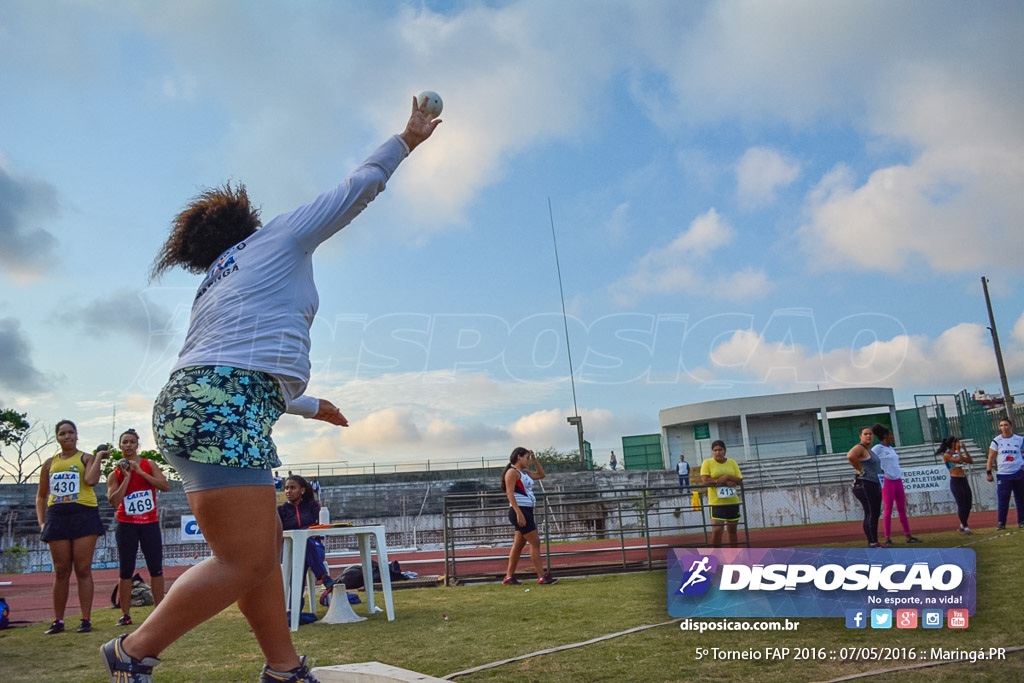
[800,25,1024,272]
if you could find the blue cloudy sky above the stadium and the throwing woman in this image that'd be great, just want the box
[0,0,1024,465]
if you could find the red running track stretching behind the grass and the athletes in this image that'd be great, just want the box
[0,510,1003,633]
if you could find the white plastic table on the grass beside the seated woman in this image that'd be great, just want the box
[281,524,394,631]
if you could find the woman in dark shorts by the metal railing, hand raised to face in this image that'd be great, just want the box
[502,446,558,586]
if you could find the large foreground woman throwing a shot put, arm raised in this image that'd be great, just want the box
[102,98,440,683]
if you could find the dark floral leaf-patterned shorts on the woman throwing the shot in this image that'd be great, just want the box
[153,366,285,470]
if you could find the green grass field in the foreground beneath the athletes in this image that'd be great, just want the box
[0,530,1024,683]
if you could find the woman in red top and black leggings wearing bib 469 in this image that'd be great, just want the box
[106,429,171,626]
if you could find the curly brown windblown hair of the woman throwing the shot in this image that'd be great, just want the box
[150,181,260,280]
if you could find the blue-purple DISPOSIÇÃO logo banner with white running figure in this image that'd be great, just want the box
[668,548,977,628]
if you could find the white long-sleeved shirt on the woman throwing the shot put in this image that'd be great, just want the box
[172,135,409,417]
